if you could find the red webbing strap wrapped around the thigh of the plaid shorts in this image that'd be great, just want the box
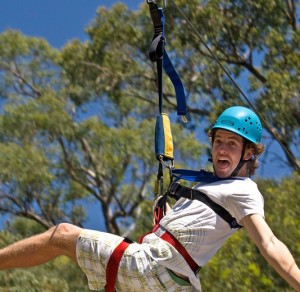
[105,238,131,292]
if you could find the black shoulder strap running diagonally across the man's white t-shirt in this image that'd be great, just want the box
[167,182,242,228]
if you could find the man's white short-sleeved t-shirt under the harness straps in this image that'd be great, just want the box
[143,177,264,290]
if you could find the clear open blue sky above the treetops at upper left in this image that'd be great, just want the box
[0,0,146,48]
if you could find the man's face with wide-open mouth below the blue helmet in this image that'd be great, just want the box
[212,129,246,178]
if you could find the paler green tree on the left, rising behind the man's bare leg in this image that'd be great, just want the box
[0,25,201,234]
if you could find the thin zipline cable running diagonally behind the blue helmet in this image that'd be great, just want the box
[170,0,300,171]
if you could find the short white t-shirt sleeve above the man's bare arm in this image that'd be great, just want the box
[226,192,264,223]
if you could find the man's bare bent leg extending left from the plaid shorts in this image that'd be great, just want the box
[0,223,81,270]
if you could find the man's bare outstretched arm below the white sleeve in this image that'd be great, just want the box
[242,214,300,291]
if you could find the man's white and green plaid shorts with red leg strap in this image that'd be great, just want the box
[77,229,193,292]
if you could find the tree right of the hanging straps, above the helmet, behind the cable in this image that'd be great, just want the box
[164,0,300,171]
